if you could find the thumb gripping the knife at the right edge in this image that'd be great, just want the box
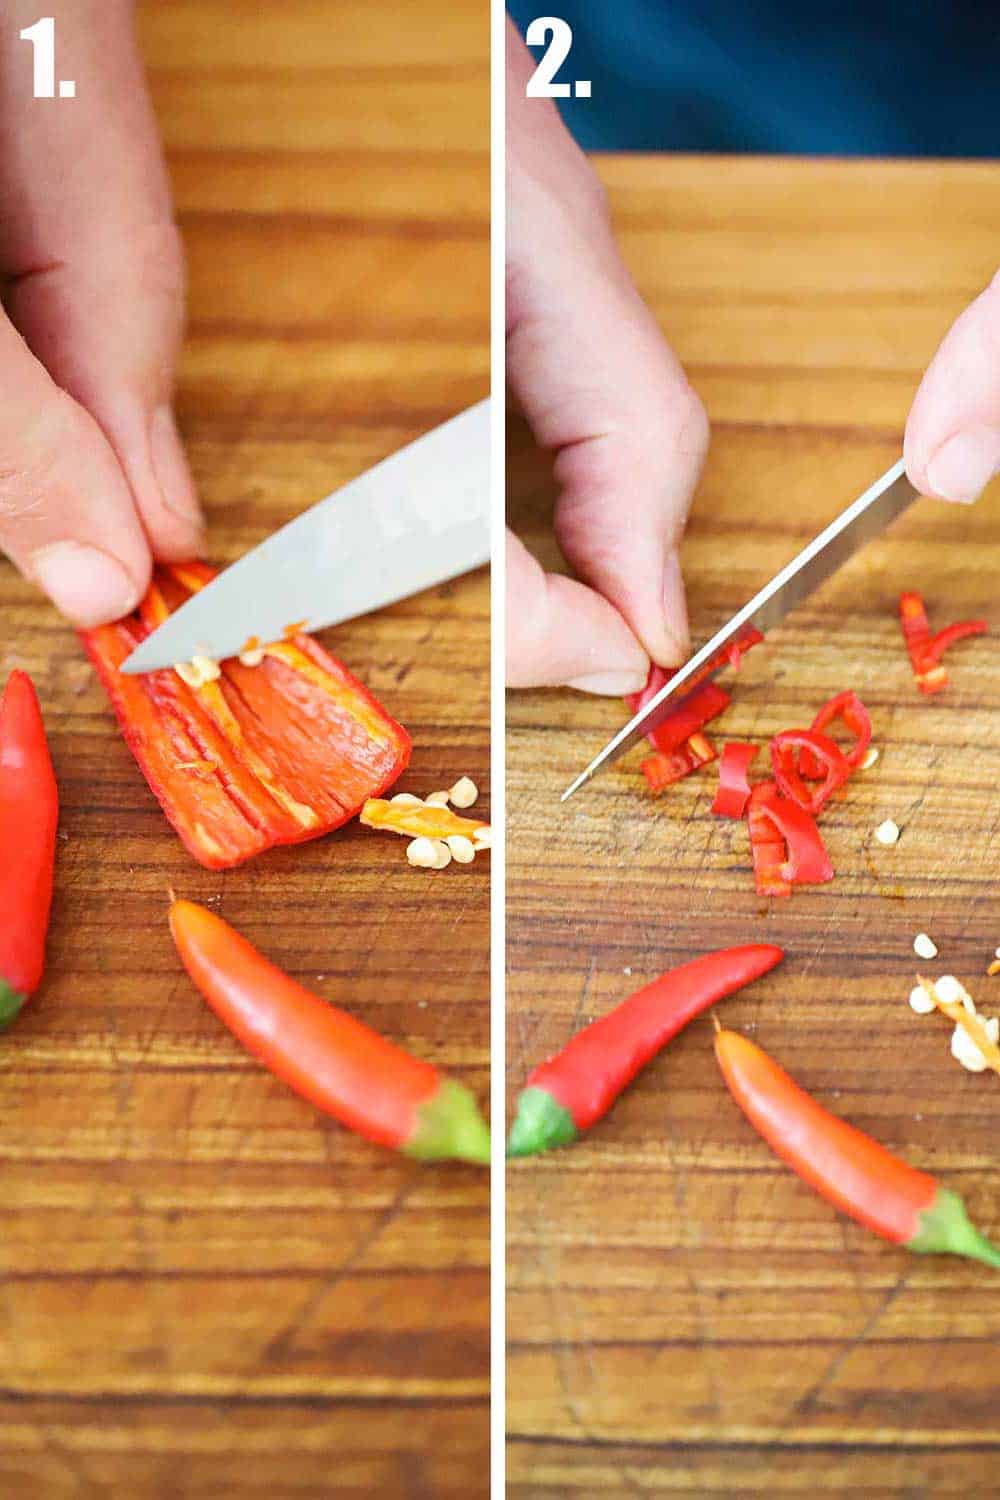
[903,275,1000,504]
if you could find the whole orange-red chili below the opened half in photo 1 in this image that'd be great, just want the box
[169,902,490,1164]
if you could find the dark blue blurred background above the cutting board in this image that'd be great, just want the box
[510,0,1000,156]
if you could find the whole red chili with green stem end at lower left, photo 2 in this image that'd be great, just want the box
[507,944,784,1157]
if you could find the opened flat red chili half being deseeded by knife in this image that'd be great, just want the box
[82,563,409,870]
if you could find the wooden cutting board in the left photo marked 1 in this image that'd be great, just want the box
[0,0,489,1500]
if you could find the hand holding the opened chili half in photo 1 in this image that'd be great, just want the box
[0,0,202,626]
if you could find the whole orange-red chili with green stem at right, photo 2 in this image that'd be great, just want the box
[715,1031,1000,1268]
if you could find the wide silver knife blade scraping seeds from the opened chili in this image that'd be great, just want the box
[121,401,490,674]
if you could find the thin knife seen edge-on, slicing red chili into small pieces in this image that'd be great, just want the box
[561,459,918,803]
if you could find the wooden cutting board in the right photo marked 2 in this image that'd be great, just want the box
[507,158,1000,1500]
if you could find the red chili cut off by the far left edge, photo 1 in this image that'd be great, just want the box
[0,672,58,1031]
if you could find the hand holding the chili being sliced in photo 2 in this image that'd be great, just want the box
[507,14,708,695]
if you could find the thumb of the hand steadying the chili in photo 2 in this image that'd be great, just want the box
[507,531,649,698]
